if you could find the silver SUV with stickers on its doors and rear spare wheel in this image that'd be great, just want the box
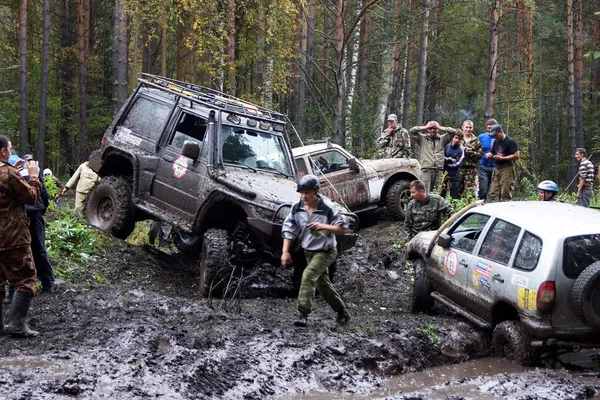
[407,202,600,365]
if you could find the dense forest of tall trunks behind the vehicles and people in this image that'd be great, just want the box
[0,0,600,183]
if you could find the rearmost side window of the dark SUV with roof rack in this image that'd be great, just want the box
[121,97,171,140]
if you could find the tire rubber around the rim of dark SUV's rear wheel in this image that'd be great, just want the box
[85,176,135,240]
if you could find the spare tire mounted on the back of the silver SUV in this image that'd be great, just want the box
[571,261,600,329]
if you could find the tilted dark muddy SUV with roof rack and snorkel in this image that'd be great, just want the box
[85,75,358,295]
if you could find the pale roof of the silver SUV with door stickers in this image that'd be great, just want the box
[471,201,600,238]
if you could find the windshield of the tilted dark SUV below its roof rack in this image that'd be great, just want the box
[221,125,292,176]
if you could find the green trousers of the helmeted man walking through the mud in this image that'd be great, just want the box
[298,249,346,314]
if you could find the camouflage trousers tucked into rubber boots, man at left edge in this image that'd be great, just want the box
[0,245,36,294]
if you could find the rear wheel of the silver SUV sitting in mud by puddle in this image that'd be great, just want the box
[492,321,535,366]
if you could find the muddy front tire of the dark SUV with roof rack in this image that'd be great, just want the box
[199,229,231,297]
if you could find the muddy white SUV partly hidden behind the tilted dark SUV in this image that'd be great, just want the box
[292,141,421,220]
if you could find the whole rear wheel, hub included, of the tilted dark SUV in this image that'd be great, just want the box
[85,176,135,239]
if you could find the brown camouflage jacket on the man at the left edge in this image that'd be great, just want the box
[0,162,42,251]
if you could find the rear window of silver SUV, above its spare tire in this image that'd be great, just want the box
[563,235,600,279]
